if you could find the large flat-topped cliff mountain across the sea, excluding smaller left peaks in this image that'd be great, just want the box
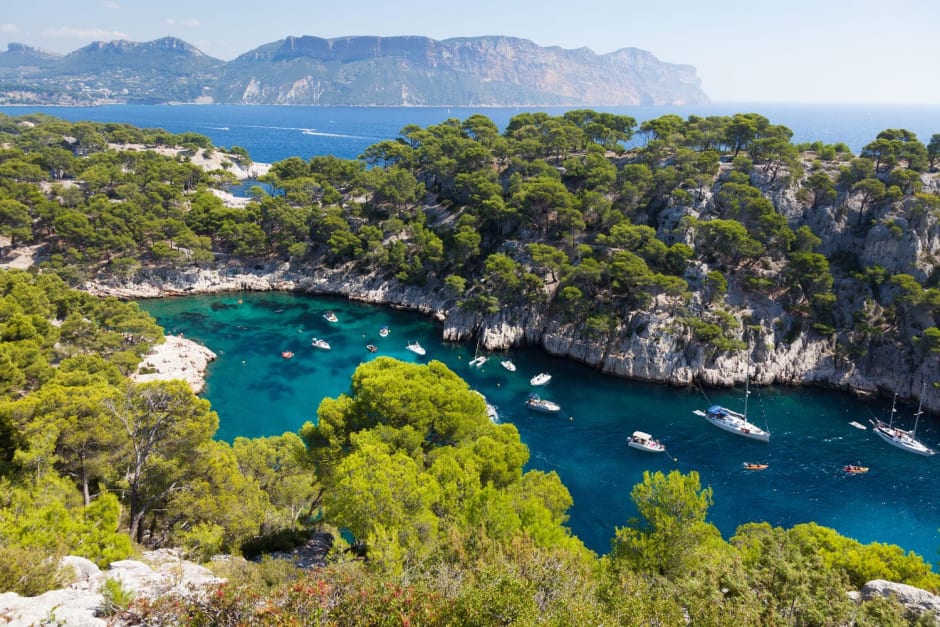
[214,36,708,106]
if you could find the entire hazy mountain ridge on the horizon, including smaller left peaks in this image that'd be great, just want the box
[0,36,709,106]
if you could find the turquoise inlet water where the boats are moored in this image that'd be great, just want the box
[140,293,940,562]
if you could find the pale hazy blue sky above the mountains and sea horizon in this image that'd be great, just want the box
[0,0,940,105]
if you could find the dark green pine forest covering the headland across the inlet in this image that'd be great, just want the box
[0,110,940,372]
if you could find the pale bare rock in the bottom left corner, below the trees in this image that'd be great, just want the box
[0,549,224,627]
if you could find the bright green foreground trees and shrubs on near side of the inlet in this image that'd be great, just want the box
[0,272,940,625]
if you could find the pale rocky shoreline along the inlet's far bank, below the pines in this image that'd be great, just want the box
[83,262,940,411]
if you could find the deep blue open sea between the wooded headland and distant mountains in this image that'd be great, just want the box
[0,103,940,163]
